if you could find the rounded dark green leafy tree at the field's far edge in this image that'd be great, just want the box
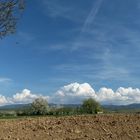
[82,98,102,114]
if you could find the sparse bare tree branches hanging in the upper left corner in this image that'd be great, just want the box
[0,0,25,38]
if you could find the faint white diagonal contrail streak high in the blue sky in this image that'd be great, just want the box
[82,0,103,32]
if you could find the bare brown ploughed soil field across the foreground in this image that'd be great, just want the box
[0,114,140,140]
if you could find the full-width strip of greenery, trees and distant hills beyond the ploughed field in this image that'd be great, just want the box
[0,98,140,119]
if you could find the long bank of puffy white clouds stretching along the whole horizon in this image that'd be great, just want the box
[0,83,140,105]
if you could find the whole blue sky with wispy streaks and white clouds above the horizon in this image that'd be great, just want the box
[0,0,140,105]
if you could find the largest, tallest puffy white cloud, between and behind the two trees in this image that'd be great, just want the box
[51,83,96,104]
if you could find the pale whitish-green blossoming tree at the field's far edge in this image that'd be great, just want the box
[31,98,49,115]
